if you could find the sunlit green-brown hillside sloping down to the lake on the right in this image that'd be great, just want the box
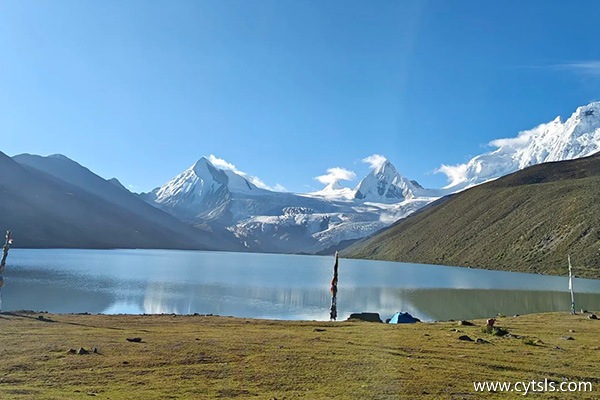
[343,154,600,278]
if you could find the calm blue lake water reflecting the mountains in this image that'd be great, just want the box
[1,249,600,320]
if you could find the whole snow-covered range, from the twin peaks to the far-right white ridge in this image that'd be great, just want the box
[141,103,600,253]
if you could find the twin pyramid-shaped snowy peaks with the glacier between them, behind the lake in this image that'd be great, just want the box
[141,157,432,253]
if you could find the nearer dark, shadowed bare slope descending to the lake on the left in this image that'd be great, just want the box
[0,153,237,250]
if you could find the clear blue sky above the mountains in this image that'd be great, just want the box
[0,0,600,192]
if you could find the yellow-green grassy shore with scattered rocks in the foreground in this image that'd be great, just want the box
[0,312,600,399]
